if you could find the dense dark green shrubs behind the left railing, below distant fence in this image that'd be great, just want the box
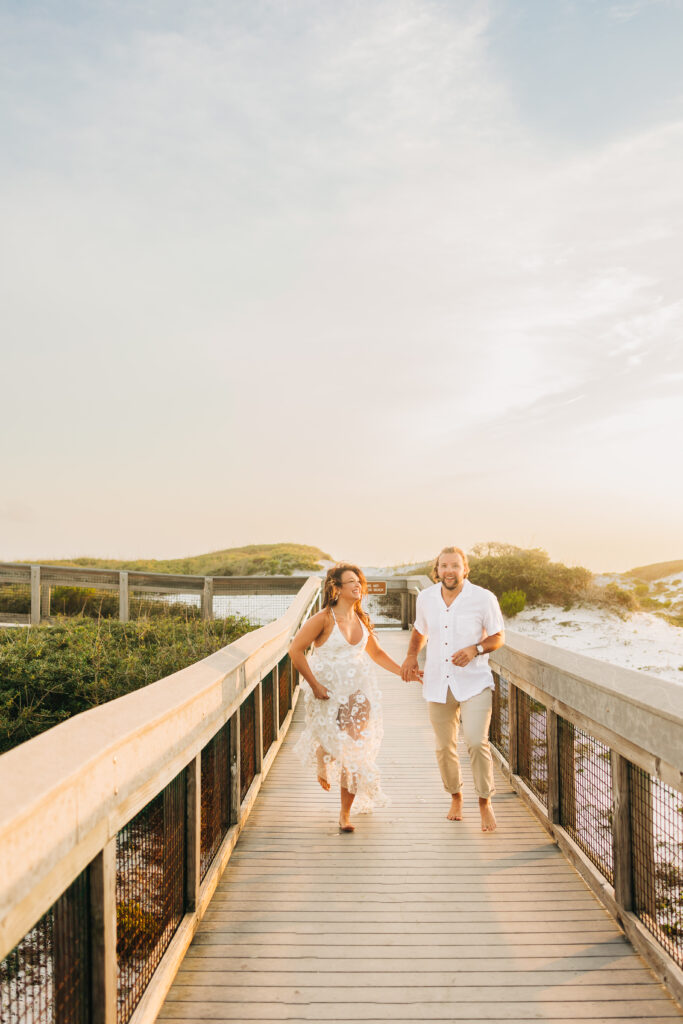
[0,616,254,753]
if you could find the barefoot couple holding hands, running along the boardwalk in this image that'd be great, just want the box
[290,548,505,831]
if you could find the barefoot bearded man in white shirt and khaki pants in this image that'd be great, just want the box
[401,548,505,831]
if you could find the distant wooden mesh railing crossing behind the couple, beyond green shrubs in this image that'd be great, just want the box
[0,562,421,626]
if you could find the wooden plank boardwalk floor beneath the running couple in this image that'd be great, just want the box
[160,632,682,1024]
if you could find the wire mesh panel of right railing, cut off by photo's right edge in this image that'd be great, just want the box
[629,764,683,967]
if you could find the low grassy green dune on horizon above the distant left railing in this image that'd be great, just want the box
[20,543,331,575]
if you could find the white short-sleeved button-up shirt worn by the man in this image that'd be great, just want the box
[415,580,505,703]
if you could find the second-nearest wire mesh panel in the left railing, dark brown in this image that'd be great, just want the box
[116,771,185,1024]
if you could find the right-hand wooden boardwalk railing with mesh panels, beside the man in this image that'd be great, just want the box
[489,633,683,999]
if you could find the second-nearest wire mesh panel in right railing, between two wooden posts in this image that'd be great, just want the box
[557,718,614,883]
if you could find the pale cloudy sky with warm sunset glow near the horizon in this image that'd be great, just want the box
[0,0,683,570]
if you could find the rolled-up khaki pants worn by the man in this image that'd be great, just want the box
[429,688,496,797]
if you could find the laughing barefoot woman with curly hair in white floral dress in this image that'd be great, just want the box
[290,562,400,833]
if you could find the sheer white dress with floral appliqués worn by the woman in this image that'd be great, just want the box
[296,621,389,812]
